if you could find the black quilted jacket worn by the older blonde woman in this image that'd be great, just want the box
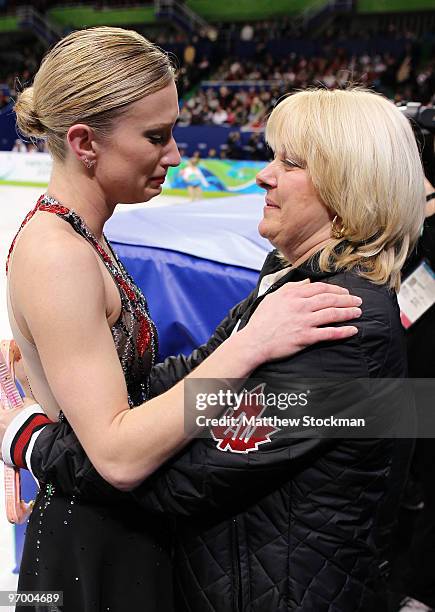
[32,254,412,612]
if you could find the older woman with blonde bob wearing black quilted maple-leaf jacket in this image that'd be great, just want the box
[134,88,425,612]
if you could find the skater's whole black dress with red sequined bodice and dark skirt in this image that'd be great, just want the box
[7,196,173,612]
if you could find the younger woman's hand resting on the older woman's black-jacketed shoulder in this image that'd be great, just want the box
[239,282,362,364]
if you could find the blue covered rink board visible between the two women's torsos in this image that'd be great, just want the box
[112,243,258,359]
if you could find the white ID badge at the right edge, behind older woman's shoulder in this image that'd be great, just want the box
[397,261,435,329]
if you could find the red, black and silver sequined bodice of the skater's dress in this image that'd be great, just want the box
[6,195,158,407]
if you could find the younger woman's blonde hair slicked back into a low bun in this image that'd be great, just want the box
[15,27,175,160]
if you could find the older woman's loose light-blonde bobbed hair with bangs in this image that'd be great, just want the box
[266,87,425,289]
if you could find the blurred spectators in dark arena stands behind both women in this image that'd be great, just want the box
[0,8,435,159]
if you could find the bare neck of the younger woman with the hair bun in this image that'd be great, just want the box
[47,160,116,240]
